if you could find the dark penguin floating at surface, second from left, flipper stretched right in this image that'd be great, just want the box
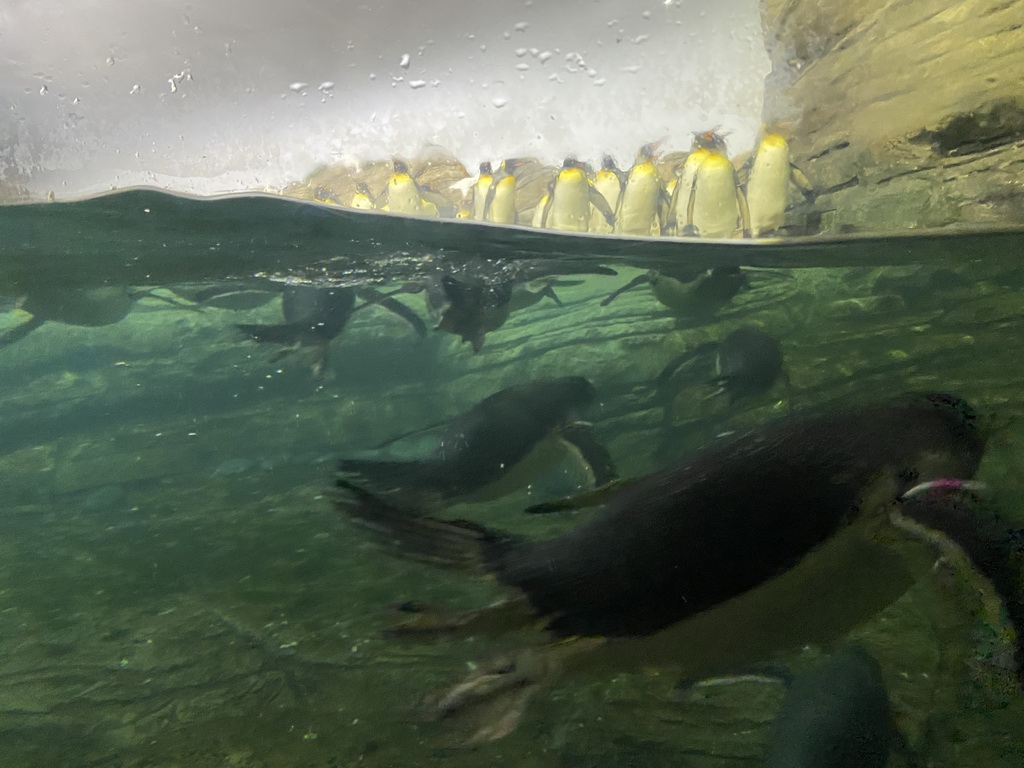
[236,285,427,379]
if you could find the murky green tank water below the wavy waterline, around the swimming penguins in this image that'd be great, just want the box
[0,191,1024,768]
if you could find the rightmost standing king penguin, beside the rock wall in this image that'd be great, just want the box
[739,133,814,238]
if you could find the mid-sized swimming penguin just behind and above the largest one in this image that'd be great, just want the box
[338,376,615,515]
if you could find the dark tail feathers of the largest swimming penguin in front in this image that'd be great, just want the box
[334,477,519,575]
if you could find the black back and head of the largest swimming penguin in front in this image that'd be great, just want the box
[490,394,984,637]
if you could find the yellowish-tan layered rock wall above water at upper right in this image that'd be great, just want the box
[762,0,1024,232]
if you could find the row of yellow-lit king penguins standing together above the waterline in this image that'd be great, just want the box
[313,130,814,238]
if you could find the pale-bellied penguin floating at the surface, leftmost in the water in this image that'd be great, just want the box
[0,286,182,347]
